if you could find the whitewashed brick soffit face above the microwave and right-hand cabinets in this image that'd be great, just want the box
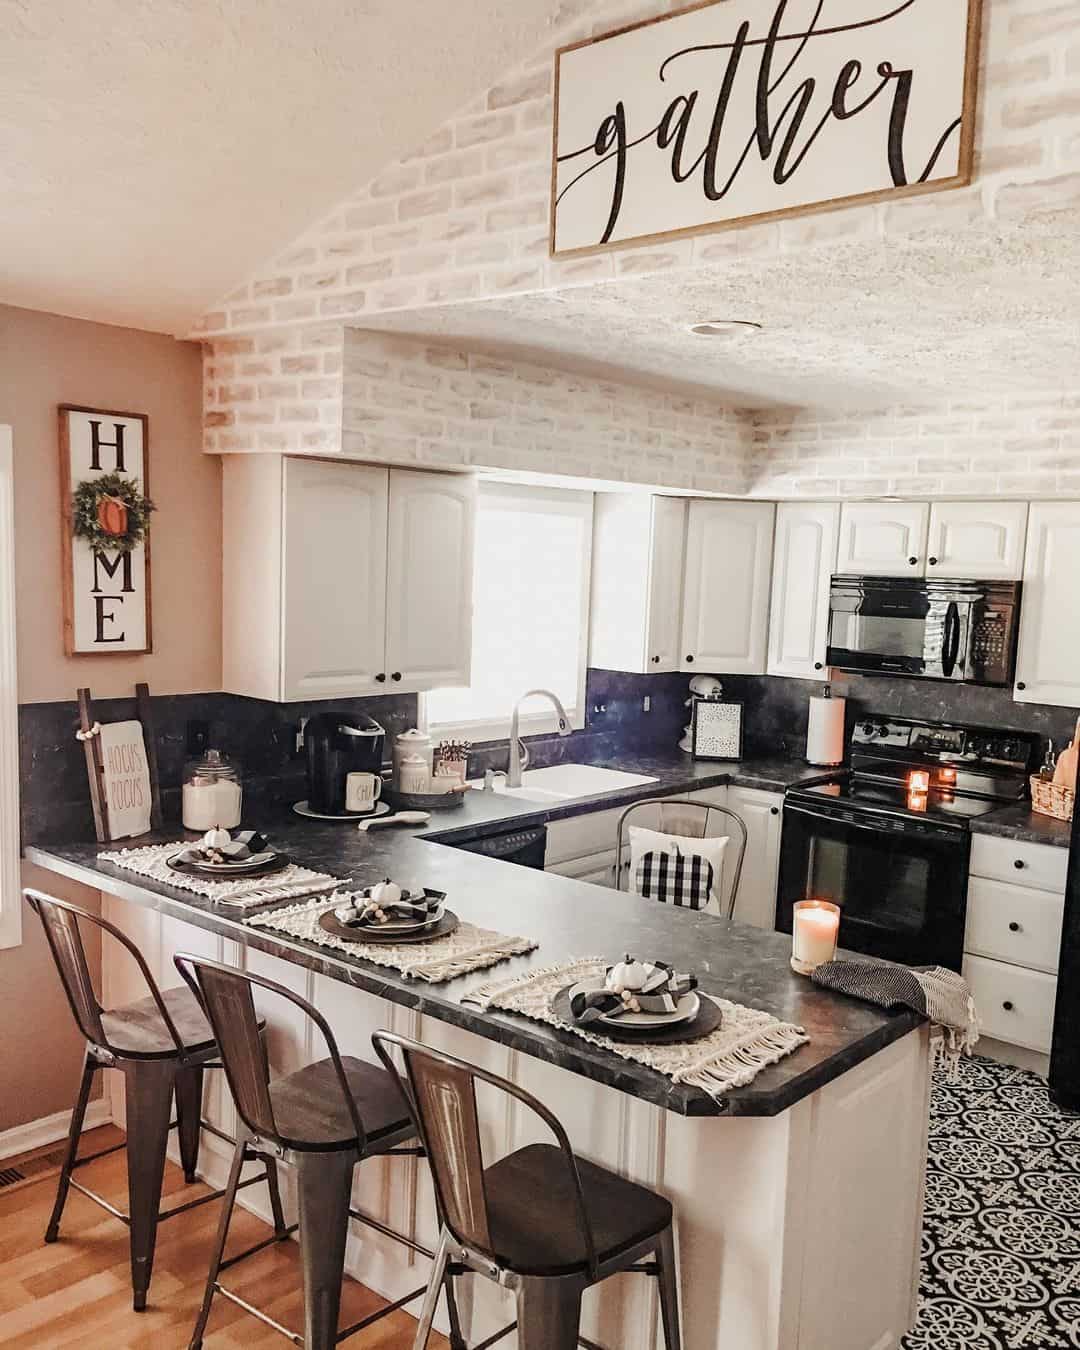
[749,392,1080,498]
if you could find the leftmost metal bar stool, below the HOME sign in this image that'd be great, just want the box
[23,890,285,1312]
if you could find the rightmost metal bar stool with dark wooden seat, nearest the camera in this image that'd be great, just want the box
[373,1031,682,1350]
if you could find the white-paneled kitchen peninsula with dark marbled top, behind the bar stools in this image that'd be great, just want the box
[27,788,929,1350]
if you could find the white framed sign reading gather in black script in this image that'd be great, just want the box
[549,0,981,257]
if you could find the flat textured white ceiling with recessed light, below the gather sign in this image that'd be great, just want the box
[369,216,1080,409]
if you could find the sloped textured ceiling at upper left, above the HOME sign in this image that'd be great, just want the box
[0,0,569,332]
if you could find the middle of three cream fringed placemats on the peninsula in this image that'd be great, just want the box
[244,892,537,984]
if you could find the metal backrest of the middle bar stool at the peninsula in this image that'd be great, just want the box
[173,952,366,1150]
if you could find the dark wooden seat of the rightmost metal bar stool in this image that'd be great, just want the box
[483,1143,672,1276]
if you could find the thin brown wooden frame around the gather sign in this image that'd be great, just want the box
[548,0,983,259]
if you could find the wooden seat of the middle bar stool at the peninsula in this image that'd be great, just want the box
[269,1054,416,1153]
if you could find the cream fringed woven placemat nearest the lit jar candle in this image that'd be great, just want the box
[466,956,810,1102]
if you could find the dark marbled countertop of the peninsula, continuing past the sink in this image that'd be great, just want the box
[26,759,918,1116]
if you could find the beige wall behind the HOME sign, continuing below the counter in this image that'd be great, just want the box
[0,306,221,1133]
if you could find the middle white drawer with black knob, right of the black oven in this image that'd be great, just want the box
[964,876,1065,975]
